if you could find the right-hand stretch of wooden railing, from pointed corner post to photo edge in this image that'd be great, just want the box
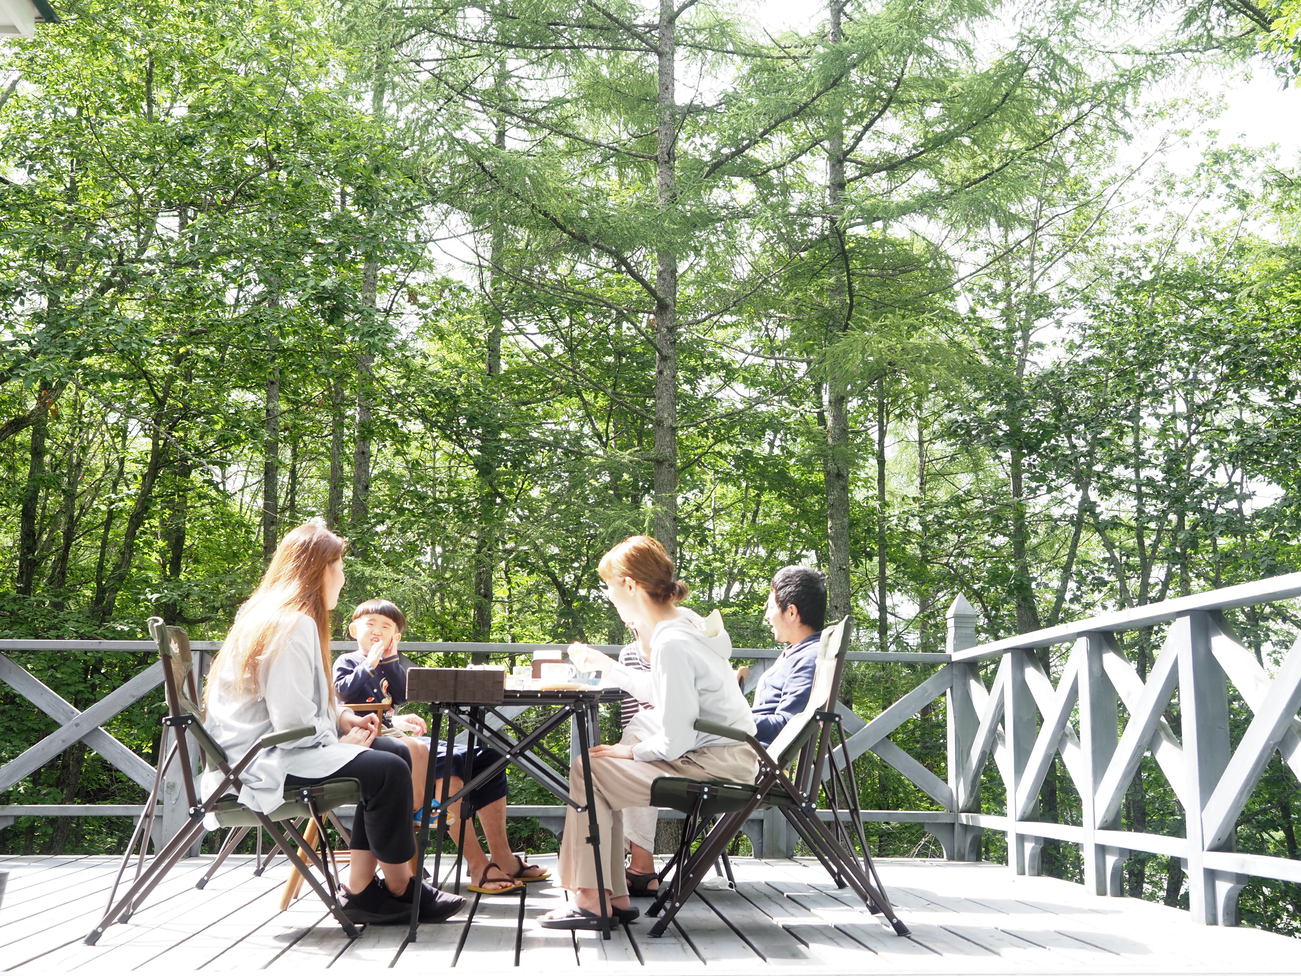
[948,573,1301,925]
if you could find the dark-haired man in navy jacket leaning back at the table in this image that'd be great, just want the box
[752,566,826,746]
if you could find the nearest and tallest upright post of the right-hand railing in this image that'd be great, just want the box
[1170,610,1229,925]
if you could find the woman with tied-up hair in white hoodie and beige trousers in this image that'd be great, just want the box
[541,535,758,929]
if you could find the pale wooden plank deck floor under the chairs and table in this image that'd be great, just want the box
[0,858,1301,976]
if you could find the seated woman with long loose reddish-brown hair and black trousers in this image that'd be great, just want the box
[206,523,464,923]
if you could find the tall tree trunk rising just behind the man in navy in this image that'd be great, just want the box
[822,0,852,619]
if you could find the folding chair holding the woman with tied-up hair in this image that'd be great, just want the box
[647,617,908,936]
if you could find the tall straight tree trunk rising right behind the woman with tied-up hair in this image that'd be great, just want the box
[653,0,678,560]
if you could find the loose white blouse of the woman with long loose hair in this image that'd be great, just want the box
[203,613,366,813]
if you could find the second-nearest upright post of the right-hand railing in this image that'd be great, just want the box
[1079,632,1120,895]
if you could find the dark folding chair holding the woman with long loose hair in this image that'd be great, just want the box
[85,617,362,945]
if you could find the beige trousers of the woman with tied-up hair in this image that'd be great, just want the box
[557,739,758,898]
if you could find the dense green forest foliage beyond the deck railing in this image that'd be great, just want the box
[0,0,1301,942]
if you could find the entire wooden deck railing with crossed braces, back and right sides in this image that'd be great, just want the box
[0,573,1301,925]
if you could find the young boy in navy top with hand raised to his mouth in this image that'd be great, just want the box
[334,600,550,894]
